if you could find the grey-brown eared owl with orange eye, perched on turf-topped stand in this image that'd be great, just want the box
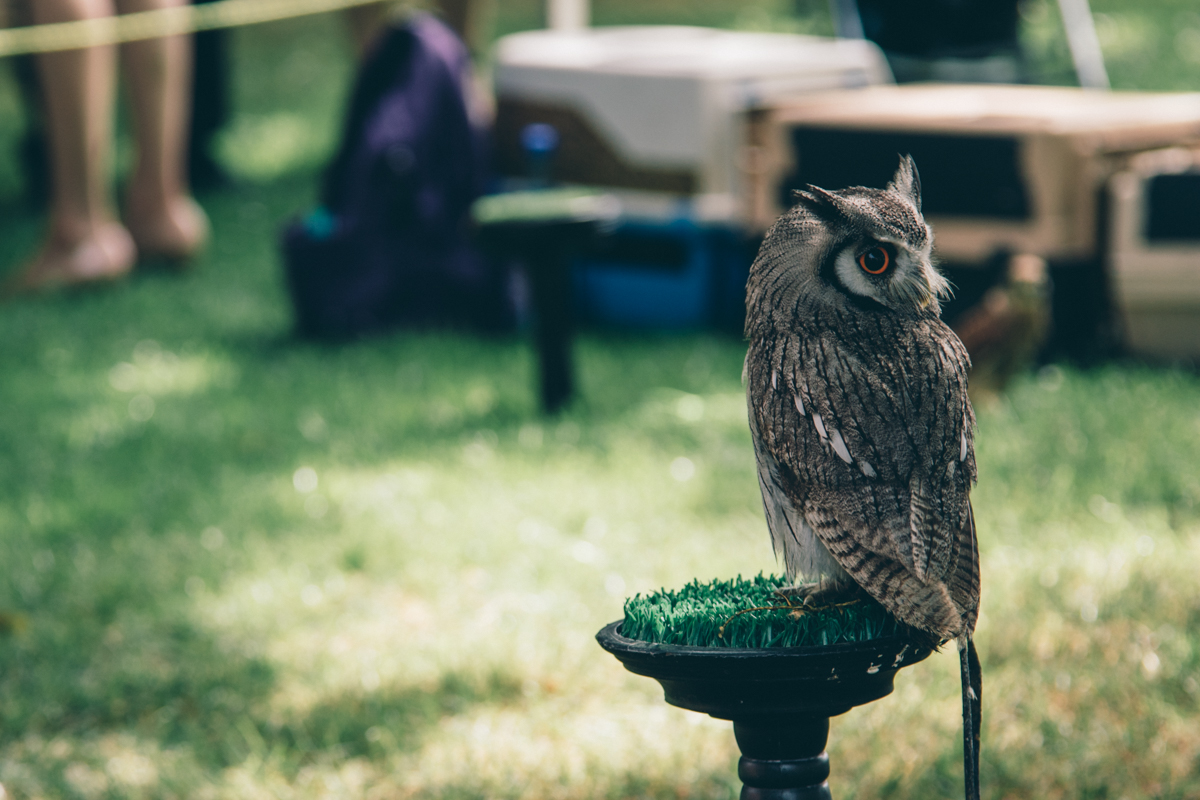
[743,156,979,787]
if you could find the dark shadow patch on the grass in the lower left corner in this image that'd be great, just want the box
[0,606,521,775]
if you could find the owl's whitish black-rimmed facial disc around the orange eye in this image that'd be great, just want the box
[834,237,949,313]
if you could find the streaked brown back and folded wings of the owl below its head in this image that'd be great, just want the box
[745,313,979,638]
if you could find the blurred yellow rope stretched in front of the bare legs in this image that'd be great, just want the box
[0,0,384,56]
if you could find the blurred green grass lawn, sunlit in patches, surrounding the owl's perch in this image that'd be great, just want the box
[0,0,1200,800]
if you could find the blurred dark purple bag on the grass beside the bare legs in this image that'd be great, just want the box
[283,14,515,338]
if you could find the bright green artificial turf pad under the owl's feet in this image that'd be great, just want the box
[620,573,902,648]
